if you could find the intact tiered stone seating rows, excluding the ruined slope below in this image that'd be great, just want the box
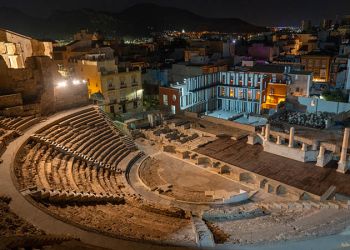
[16,107,137,203]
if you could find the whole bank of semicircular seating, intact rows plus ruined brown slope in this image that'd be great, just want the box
[15,107,195,243]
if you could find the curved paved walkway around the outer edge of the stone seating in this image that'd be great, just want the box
[0,107,191,250]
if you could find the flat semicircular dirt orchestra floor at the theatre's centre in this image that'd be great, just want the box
[140,153,249,202]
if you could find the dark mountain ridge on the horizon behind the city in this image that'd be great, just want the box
[0,3,264,39]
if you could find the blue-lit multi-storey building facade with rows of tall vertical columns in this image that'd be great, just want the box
[160,71,268,114]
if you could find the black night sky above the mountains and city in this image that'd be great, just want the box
[0,0,350,26]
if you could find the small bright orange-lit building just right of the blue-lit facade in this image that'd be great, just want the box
[262,82,287,109]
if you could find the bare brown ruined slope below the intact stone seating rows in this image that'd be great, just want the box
[49,204,195,245]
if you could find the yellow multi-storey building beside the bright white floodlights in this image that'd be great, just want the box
[74,54,143,114]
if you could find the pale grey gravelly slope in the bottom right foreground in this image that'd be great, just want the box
[210,209,350,244]
